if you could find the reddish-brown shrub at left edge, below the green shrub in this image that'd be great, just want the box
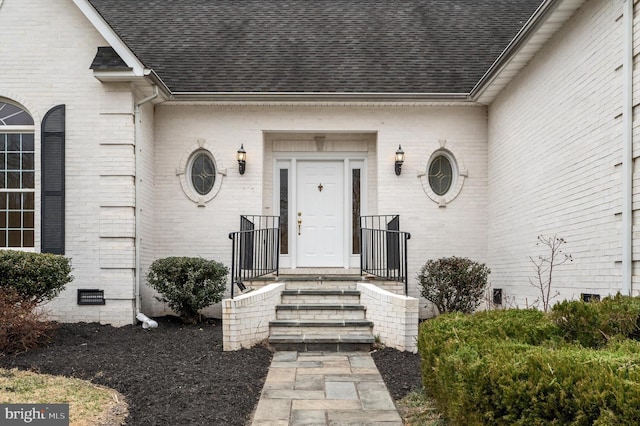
[0,288,53,355]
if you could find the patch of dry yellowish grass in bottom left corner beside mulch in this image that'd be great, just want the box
[0,368,126,426]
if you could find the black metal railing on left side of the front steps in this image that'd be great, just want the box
[229,215,280,299]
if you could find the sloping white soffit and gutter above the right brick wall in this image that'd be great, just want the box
[471,0,586,105]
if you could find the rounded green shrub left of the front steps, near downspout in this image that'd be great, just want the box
[147,257,228,324]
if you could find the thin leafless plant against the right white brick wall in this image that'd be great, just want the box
[529,235,573,312]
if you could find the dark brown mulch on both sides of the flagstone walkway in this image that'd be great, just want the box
[0,316,420,426]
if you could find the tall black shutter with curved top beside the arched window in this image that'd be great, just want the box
[40,105,65,254]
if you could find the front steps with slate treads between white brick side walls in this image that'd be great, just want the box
[269,277,375,352]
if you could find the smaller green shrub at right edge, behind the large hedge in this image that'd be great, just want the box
[551,294,640,348]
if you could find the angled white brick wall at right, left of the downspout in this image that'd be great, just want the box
[488,0,624,307]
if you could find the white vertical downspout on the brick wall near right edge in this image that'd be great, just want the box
[620,0,633,295]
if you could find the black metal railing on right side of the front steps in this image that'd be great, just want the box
[360,215,411,296]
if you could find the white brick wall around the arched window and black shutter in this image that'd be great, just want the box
[0,0,133,325]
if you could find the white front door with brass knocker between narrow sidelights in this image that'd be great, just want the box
[294,160,345,267]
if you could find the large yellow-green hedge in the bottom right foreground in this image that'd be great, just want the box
[418,310,640,425]
